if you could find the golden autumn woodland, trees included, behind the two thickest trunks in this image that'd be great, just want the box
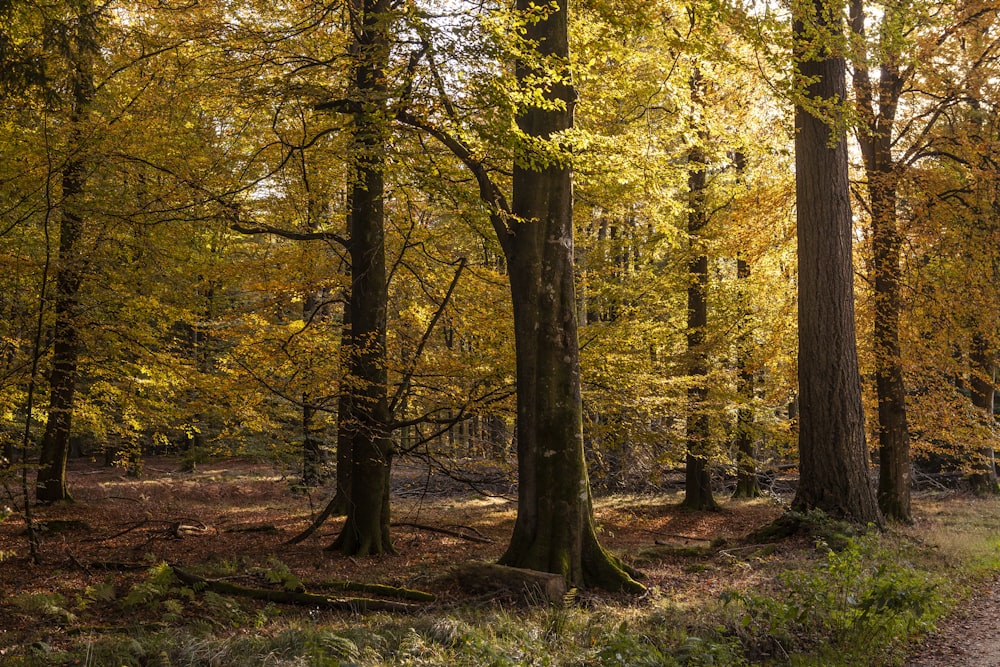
[0,0,1000,664]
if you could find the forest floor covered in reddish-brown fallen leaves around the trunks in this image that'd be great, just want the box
[0,458,1000,667]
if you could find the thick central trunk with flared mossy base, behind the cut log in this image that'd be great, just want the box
[500,0,643,591]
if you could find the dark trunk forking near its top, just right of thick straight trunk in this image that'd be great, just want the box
[851,0,911,523]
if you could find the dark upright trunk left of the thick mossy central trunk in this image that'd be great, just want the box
[330,0,393,555]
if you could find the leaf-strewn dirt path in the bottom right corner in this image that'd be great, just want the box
[906,579,1000,667]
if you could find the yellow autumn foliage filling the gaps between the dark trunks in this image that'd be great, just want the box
[0,2,998,516]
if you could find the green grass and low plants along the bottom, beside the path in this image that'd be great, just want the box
[0,490,1000,667]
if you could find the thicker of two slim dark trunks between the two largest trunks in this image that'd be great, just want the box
[681,73,719,510]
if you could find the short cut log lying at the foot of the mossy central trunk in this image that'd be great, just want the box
[450,562,566,605]
